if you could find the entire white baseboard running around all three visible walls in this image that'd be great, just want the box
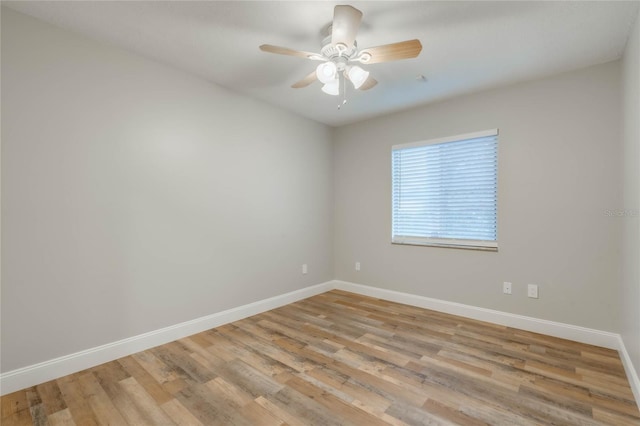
[0,280,640,412]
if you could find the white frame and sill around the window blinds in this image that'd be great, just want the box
[391,129,499,251]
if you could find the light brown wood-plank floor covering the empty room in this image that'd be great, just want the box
[1,291,640,426]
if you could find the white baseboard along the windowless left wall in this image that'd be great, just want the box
[0,282,333,395]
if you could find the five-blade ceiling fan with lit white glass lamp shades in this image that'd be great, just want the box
[260,5,422,102]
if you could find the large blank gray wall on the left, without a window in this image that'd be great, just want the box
[1,9,333,372]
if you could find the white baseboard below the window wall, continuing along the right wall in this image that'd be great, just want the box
[330,280,640,408]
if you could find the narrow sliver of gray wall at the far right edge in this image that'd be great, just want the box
[619,7,640,374]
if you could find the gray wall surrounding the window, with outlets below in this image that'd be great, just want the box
[333,62,622,332]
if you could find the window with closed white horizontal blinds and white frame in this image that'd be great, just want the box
[391,129,498,251]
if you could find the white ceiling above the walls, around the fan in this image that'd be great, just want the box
[2,1,640,126]
